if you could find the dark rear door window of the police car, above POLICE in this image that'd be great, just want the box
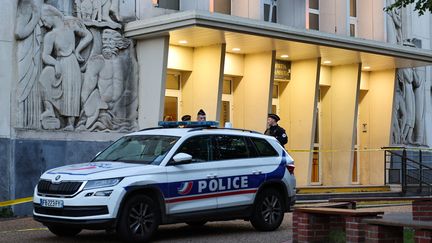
[215,135,256,160]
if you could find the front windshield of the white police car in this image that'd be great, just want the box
[93,135,180,165]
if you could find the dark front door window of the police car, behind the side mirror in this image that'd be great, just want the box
[176,136,211,162]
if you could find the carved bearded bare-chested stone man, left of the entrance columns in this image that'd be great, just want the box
[80,29,136,131]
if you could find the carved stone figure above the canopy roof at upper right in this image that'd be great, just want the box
[387,0,403,44]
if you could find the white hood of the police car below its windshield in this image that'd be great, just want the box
[42,161,162,180]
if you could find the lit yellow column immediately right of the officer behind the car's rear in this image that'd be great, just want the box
[279,59,320,186]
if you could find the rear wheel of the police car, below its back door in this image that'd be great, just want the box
[250,189,285,231]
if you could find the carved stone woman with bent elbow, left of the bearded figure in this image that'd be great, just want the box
[42,5,92,130]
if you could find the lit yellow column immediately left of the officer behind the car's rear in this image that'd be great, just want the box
[234,52,275,132]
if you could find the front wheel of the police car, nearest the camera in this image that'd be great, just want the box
[117,195,161,242]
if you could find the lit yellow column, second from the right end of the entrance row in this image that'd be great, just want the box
[320,64,361,186]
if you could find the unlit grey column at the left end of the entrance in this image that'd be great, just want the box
[137,36,169,129]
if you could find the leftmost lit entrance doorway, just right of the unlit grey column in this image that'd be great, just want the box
[163,71,181,121]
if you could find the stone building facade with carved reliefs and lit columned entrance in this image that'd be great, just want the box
[0,0,432,211]
